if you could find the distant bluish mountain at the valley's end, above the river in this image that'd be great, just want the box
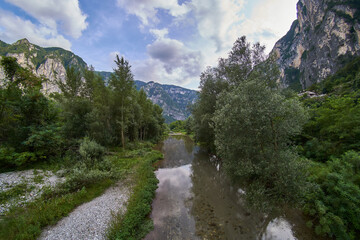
[135,81,197,123]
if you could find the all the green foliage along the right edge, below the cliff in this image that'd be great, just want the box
[298,52,360,239]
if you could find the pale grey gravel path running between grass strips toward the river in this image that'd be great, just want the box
[39,183,130,240]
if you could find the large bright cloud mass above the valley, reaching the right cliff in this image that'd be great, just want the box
[117,0,298,86]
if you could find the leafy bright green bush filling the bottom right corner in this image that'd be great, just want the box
[304,151,360,239]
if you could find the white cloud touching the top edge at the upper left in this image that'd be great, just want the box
[6,0,88,38]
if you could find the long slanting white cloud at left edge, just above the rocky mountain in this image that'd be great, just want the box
[0,9,71,50]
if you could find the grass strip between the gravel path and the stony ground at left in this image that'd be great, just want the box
[0,179,113,240]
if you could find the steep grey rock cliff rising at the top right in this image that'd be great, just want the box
[273,0,360,90]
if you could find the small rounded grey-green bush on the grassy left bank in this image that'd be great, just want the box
[79,138,105,168]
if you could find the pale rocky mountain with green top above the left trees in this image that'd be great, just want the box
[0,39,87,93]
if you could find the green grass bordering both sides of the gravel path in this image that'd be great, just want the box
[0,143,162,240]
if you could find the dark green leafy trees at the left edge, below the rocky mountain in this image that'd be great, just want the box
[0,57,61,168]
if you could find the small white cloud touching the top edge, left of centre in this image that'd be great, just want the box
[117,0,189,26]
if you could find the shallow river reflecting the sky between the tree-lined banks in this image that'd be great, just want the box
[145,136,319,240]
